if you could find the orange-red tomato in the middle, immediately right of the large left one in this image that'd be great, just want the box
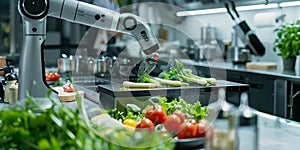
[164,114,180,133]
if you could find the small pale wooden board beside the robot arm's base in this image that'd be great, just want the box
[53,86,84,102]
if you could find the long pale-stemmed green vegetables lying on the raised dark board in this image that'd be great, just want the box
[123,60,217,88]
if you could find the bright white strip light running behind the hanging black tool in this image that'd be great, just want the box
[176,1,300,17]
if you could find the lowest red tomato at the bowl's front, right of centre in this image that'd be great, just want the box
[177,119,198,139]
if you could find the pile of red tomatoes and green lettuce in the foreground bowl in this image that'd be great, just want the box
[108,98,209,139]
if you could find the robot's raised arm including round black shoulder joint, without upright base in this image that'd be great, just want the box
[19,0,159,52]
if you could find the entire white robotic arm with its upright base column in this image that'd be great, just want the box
[18,0,159,100]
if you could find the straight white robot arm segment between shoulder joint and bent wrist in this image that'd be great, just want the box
[49,0,120,31]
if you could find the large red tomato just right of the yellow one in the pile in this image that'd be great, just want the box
[145,105,167,124]
